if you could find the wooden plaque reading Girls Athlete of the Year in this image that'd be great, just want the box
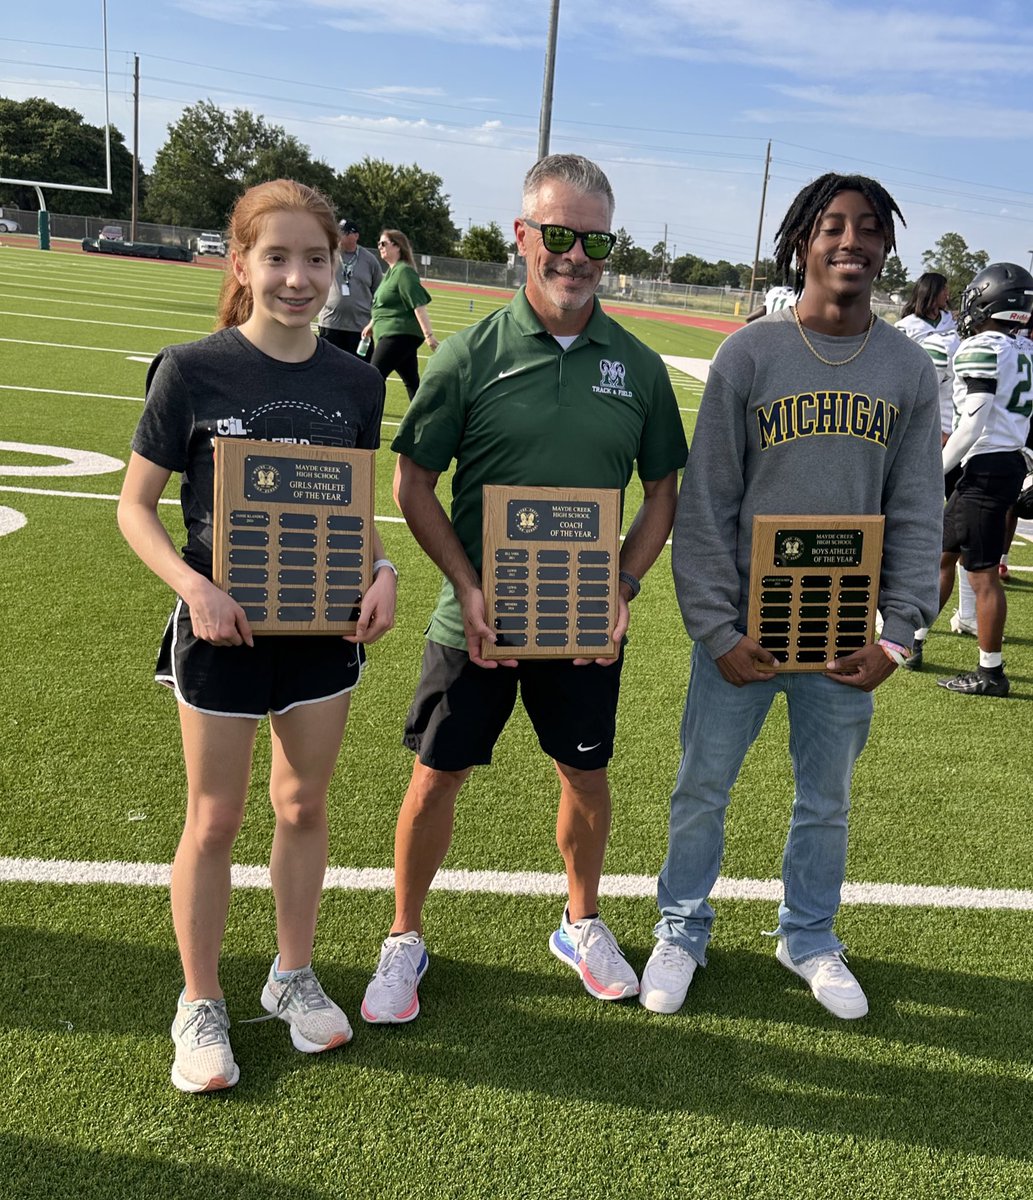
[212,438,374,635]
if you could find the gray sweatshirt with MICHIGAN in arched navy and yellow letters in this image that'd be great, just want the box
[672,310,943,659]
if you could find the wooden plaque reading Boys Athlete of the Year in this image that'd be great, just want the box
[746,516,884,671]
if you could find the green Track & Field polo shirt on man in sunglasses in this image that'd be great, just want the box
[391,284,687,649]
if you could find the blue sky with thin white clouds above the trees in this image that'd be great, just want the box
[0,0,1033,276]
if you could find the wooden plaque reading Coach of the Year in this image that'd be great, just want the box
[481,485,620,659]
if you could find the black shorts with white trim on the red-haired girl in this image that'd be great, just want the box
[155,600,366,719]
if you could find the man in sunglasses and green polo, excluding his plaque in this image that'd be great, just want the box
[362,155,687,1024]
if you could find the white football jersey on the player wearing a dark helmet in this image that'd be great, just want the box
[954,330,1033,462]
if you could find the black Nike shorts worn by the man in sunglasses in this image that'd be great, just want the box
[402,641,624,770]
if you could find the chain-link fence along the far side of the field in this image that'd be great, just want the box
[4,206,900,320]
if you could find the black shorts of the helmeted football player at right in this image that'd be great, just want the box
[943,450,1026,571]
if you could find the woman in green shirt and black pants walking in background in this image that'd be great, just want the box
[362,229,438,400]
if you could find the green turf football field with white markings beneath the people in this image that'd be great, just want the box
[0,246,1033,1200]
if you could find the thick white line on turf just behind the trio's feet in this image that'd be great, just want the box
[0,858,1033,912]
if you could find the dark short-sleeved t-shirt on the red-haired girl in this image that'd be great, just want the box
[132,329,384,577]
